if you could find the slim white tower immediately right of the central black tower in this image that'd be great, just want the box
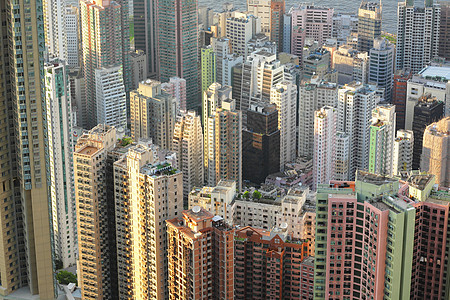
[270,81,298,170]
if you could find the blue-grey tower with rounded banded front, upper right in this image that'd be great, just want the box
[369,38,394,101]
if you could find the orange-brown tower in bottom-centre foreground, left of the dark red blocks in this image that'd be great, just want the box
[167,206,235,300]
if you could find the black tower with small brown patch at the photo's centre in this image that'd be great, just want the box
[242,103,280,183]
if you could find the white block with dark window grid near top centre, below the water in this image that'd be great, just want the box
[226,13,261,57]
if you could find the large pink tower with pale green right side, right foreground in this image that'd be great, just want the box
[314,171,415,299]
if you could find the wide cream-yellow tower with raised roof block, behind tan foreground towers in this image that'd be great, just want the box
[130,80,177,149]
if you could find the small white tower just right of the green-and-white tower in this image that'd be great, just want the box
[392,129,414,178]
